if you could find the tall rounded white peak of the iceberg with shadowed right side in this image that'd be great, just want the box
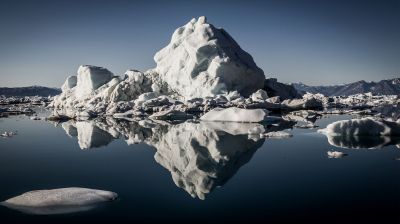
[154,16,265,98]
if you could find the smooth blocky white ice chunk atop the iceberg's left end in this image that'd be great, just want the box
[76,65,114,96]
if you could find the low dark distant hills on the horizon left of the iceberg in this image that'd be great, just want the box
[0,86,61,96]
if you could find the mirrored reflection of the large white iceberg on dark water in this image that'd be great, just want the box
[56,119,292,199]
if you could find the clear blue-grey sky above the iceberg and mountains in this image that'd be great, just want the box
[0,0,400,87]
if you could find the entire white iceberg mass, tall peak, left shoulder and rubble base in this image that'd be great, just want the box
[50,17,319,120]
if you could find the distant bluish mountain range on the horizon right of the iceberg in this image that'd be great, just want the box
[293,78,400,96]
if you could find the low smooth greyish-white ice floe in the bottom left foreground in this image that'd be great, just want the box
[0,187,118,215]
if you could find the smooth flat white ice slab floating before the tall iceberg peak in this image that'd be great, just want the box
[200,107,268,123]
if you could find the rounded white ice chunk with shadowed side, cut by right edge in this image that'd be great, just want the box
[318,118,400,136]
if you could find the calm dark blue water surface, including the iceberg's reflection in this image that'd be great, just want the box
[0,116,400,223]
